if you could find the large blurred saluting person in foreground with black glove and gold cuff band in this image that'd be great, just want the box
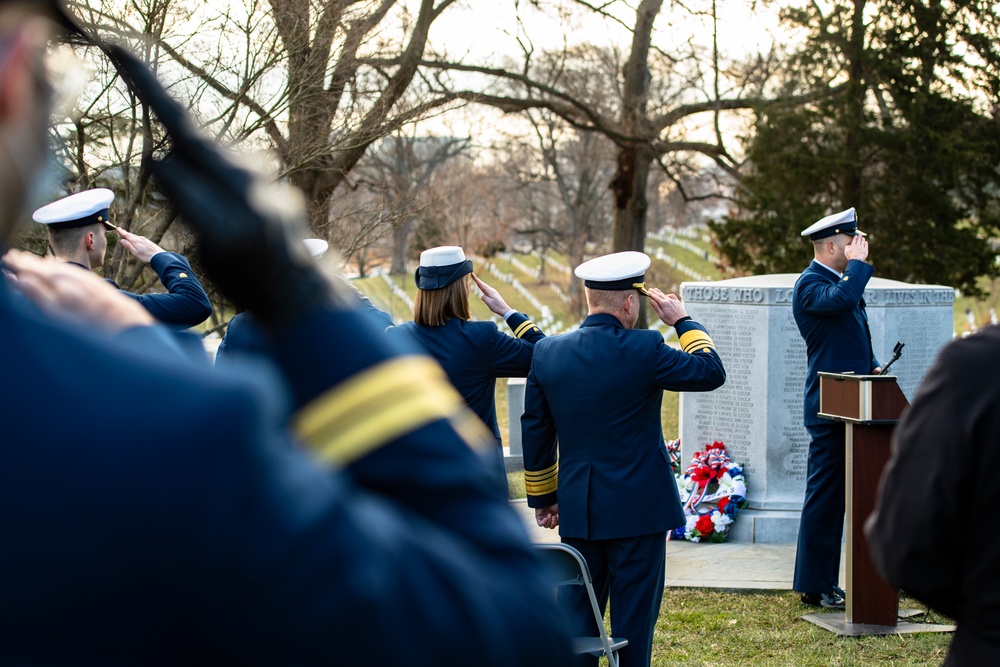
[0,0,567,667]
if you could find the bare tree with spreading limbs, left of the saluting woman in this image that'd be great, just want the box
[76,0,462,229]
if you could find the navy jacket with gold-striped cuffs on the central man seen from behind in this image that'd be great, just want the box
[521,314,726,540]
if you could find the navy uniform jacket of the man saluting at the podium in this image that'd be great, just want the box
[792,259,879,426]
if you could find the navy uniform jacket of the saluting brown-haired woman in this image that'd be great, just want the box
[387,312,545,445]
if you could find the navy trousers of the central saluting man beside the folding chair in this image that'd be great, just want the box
[560,532,667,667]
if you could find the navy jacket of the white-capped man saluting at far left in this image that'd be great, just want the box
[109,252,212,328]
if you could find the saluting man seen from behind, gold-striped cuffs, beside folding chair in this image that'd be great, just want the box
[521,252,726,667]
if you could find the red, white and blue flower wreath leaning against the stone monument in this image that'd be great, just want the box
[667,440,747,542]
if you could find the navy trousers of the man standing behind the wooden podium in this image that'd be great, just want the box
[792,422,846,593]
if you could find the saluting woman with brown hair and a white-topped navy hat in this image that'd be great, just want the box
[388,246,545,499]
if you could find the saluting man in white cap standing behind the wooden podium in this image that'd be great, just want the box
[792,208,879,609]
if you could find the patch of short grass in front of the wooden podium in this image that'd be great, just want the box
[652,588,952,667]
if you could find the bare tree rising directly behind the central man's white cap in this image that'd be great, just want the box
[390,0,796,251]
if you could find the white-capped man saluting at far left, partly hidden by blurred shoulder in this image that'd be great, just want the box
[32,188,212,328]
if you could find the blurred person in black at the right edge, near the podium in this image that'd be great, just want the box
[865,326,1000,667]
